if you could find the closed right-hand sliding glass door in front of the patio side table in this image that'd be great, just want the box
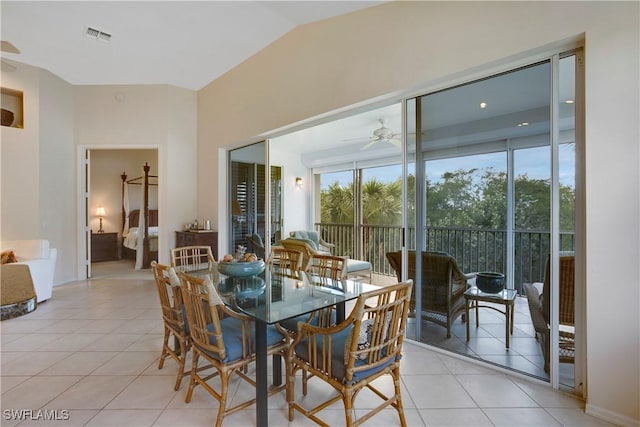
[407,56,576,392]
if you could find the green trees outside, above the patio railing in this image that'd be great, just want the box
[320,168,575,234]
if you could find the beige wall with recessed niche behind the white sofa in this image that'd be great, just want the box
[0,63,77,285]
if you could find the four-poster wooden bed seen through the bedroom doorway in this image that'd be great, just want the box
[120,163,158,269]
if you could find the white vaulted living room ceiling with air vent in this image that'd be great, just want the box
[0,0,383,90]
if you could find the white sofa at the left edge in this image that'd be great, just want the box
[0,240,58,302]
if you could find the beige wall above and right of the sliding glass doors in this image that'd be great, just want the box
[198,2,640,425]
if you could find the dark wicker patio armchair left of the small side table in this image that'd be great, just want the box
[386,251,475,338]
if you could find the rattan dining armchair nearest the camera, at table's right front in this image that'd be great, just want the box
[287,280,413,426]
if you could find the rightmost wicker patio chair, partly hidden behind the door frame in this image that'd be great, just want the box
[524,255,575,372]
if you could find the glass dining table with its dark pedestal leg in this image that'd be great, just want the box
[212,266,380,426]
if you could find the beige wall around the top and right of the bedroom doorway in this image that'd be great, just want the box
[75,85,197,264]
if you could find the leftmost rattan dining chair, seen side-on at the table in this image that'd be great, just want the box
[151,261,191,390]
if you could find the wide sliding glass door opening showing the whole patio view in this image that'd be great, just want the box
[264,49,584,388]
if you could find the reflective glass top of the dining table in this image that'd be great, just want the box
[206,266,379,324]
